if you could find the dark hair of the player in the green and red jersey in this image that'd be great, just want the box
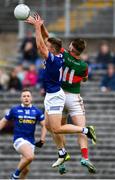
[72,38,86,54]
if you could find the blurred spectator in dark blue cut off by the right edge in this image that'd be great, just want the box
[101,64,115,92]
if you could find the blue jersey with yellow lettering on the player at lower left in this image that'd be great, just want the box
[5,105,44,144]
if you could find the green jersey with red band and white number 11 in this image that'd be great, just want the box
[62,50,88,94]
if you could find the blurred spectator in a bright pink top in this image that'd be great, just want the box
[23,64,38,87]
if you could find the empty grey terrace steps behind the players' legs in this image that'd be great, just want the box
[0,70,115,179]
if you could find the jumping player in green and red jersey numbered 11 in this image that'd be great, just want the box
[56,39,96,173]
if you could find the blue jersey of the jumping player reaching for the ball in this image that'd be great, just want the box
[44,52,64,93]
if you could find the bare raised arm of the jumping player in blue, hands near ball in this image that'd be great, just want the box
[26,15,49,59]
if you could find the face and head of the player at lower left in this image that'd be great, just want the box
[21,91,32,106]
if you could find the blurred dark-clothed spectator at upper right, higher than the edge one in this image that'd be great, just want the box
[94,41,113,69]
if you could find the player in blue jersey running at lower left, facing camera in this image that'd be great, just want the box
[0,89,46,180]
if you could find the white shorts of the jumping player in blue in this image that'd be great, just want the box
[44,89,65,114]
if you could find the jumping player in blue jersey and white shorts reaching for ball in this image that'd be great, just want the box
[27,15,95,172]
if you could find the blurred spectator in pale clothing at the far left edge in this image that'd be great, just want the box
[0,69,9,90]
